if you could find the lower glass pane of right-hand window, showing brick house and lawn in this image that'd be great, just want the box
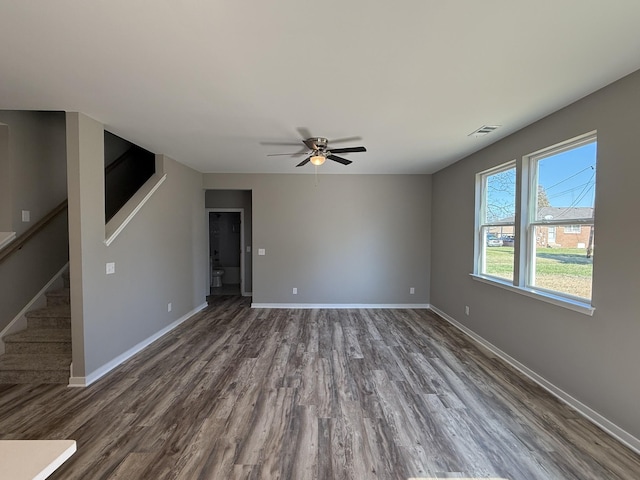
[529,225,594,299]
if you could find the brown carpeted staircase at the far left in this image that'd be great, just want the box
[0,276,71,384]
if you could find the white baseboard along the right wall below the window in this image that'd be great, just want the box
[431,305,640,454]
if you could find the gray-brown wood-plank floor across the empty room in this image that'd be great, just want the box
[0,297,640,480]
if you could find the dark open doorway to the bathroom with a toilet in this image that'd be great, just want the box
[207,208,245,295]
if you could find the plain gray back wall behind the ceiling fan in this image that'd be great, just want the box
[204,174,431,304]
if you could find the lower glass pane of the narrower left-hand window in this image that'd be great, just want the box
[481,229,515,281]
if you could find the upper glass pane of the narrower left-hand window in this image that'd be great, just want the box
[482,167,516,223]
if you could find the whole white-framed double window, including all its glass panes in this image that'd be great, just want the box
[474,133,597,305]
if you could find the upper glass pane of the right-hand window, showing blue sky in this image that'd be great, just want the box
[534,141,596,221]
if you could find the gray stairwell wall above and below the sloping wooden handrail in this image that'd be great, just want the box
[0,111,68,330]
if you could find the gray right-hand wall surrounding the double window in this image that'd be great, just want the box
[431,68,640,438]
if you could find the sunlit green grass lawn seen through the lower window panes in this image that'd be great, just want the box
[486,247,593,298]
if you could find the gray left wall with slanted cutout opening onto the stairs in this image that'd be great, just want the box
[67,113,208,377]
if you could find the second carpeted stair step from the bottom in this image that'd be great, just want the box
[4,328,71,354]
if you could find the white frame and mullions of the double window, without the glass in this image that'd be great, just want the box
[471,130,598,315]
